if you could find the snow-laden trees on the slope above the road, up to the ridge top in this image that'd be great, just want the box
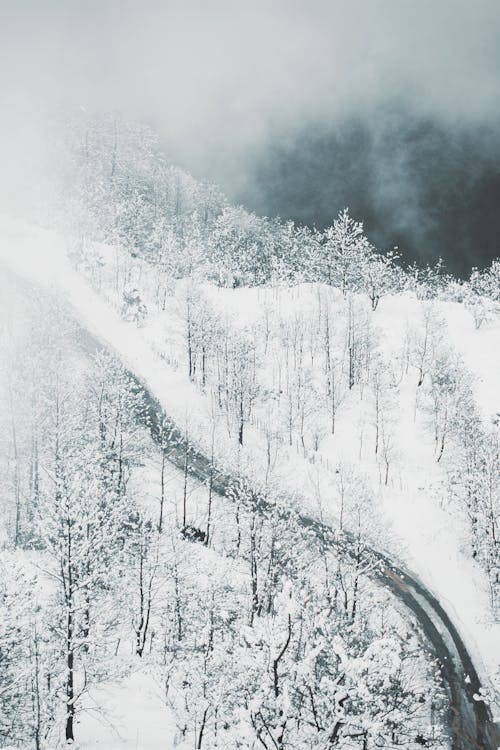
[62,113,500,616]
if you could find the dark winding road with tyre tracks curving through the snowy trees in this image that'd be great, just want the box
[2,272,500,750]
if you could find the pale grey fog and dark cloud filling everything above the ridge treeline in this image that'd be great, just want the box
[0,0,500,272]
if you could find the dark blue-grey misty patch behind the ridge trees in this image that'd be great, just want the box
[238,108,500,278]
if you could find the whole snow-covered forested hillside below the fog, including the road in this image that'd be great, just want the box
[0,112,500,750]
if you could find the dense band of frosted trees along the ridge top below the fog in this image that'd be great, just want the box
[61,117,499,307]
